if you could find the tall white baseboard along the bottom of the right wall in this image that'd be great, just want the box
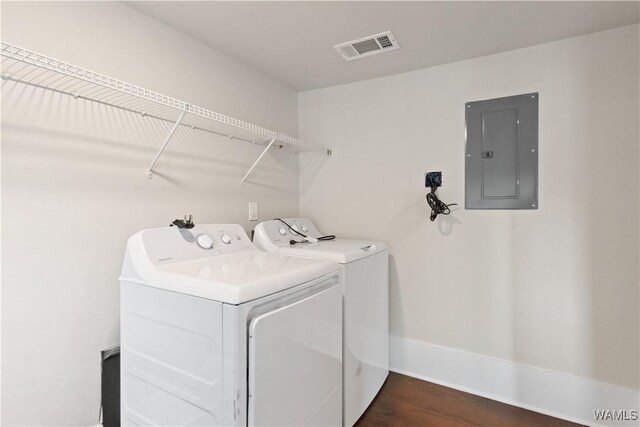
[390,336,640,426]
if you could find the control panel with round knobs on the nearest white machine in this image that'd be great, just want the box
[142,224,255,264]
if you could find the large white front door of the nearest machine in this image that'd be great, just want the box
[248,284,342,426]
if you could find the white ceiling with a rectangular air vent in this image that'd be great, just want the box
[126,1,640,91]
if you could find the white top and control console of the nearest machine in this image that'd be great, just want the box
[121,224,340,304]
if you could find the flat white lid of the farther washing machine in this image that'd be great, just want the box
[277,239,387,264]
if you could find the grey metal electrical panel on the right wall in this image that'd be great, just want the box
[465,93,538,209]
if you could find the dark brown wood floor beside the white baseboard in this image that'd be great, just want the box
[356,372,578,427]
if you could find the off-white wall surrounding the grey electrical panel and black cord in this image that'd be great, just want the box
[298,25,640,392]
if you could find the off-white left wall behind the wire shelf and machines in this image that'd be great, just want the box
[2,2,298,425]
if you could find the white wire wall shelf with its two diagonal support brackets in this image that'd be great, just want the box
[0,42,324,182]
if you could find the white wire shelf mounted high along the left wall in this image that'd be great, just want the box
[0,42,324,180]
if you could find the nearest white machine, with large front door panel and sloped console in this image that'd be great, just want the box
[120,225,343,426]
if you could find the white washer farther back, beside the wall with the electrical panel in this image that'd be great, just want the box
[253,218,389,426]
